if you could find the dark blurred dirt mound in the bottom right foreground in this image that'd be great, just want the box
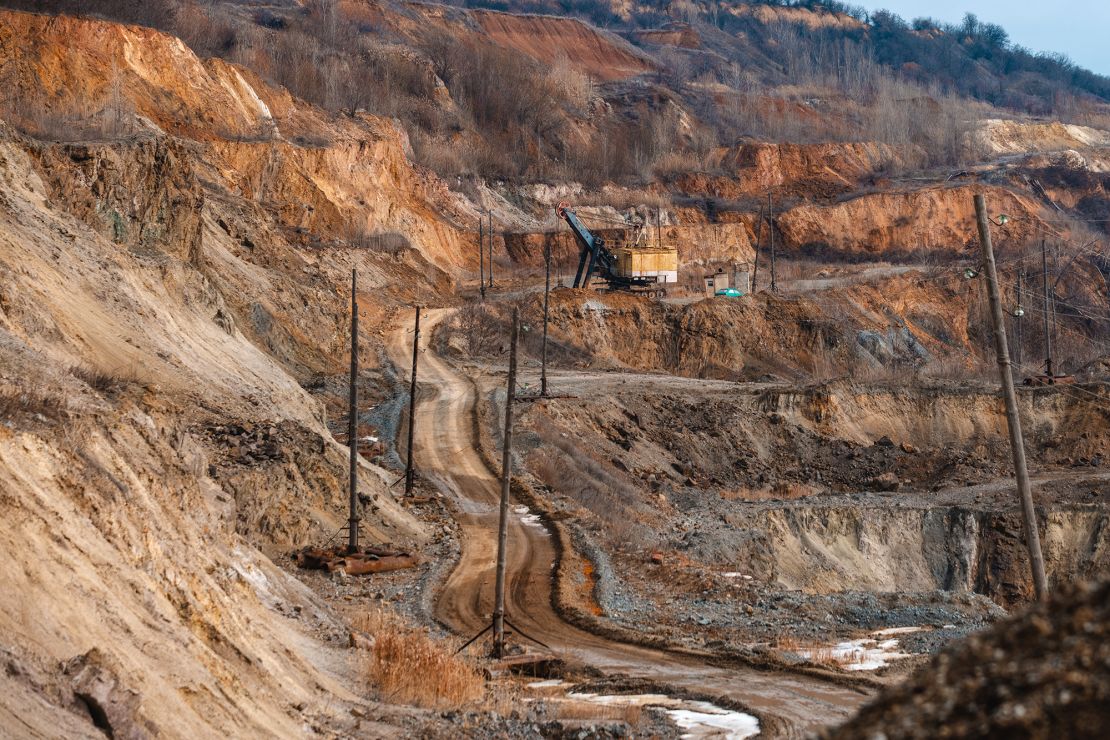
[823,582,1110,740]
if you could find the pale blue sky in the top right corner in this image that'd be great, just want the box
[848,0,1110,75]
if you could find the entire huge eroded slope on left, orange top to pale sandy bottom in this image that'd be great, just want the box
[0,13,456,737]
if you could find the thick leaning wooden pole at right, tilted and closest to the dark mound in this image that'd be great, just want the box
[975,194,1048,601]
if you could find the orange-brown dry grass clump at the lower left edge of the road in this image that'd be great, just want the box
[354,611,485,709]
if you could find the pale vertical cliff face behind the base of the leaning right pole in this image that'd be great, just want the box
[730,504,1110,607]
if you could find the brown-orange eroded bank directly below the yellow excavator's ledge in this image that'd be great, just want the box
[508,275,999,381]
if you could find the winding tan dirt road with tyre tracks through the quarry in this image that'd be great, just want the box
[387,310,867,734]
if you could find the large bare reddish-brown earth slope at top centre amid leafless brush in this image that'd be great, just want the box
[474,11,655,80]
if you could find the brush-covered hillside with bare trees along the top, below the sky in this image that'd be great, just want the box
[2,0,1110,184]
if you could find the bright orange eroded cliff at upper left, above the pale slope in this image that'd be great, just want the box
[0,12,466,268]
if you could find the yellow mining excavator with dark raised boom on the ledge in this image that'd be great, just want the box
[555,203,678,297]
